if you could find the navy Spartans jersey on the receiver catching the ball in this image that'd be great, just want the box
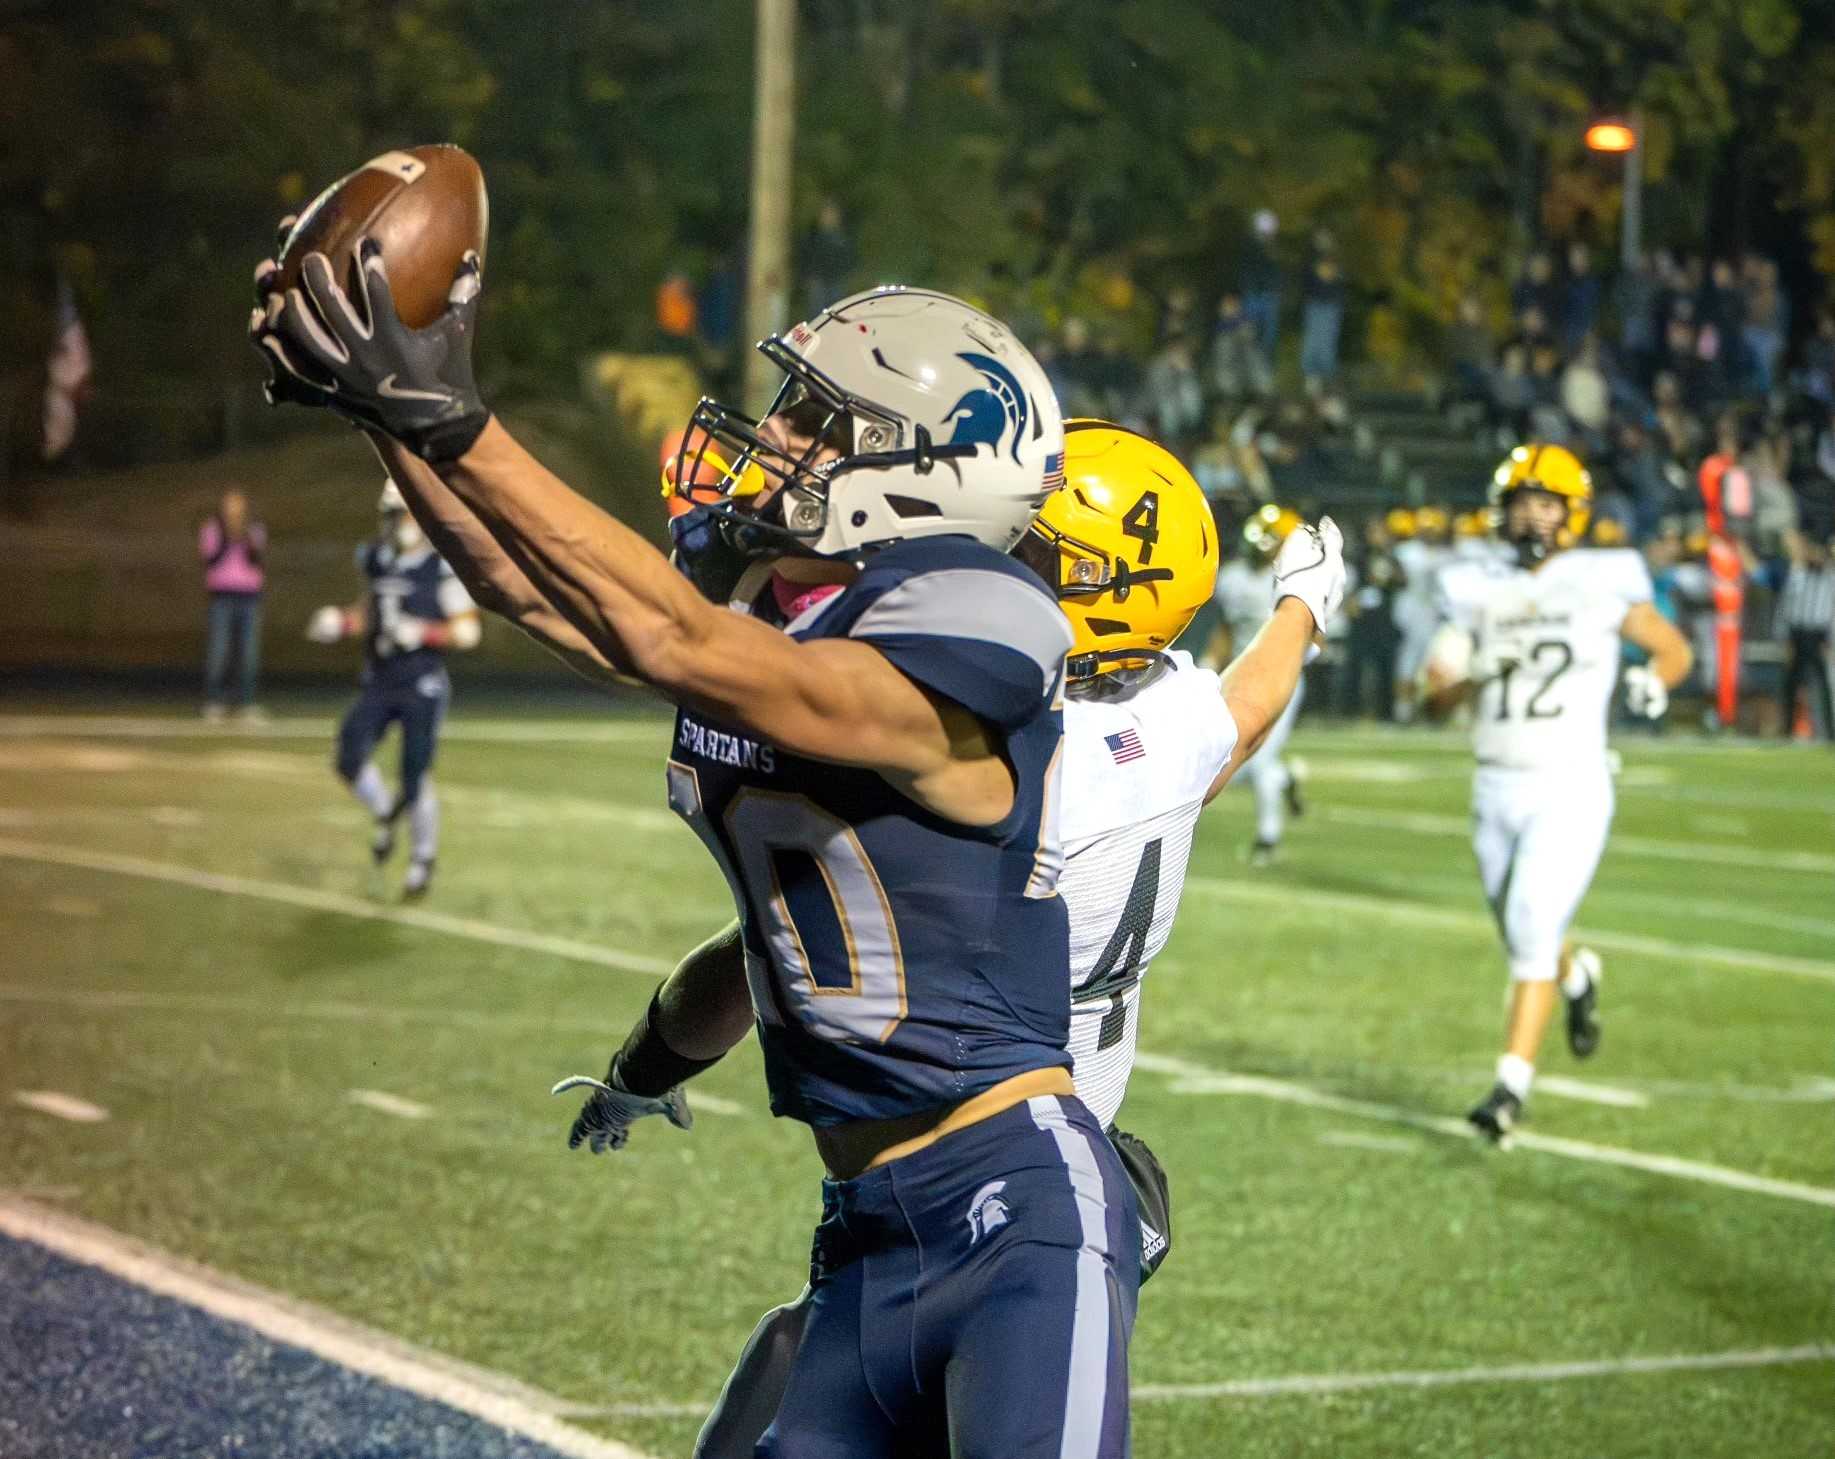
[668,536,1070,1125]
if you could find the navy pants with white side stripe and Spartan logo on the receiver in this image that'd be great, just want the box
[758,1096,1140,1459]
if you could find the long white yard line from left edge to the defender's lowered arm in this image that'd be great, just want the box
[0,837,675,976]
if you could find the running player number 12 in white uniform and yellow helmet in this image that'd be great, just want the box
[1426,444,1692,1142]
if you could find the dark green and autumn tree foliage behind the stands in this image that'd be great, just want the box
[0,0,1835,473]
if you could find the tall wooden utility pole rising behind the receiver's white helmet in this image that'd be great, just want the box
[745,0,796,411]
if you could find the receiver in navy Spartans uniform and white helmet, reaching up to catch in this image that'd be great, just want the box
[251,244,1140,1459]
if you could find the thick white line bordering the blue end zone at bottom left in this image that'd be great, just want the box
[0,1191,651,1459]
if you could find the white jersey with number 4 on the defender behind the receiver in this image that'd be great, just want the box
[1057,653,1240,1125]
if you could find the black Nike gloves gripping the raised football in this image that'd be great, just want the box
[250,239,490,464]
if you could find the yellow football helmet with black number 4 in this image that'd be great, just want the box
[1013,420,1217,679]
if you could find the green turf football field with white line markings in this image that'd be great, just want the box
[0,697,1835,1459]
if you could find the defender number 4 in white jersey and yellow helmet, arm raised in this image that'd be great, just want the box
[609,420,1343,1459]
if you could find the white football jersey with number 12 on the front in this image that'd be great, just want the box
[1440,547,1652,769]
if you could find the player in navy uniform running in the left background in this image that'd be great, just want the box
[306,479,483,899]
